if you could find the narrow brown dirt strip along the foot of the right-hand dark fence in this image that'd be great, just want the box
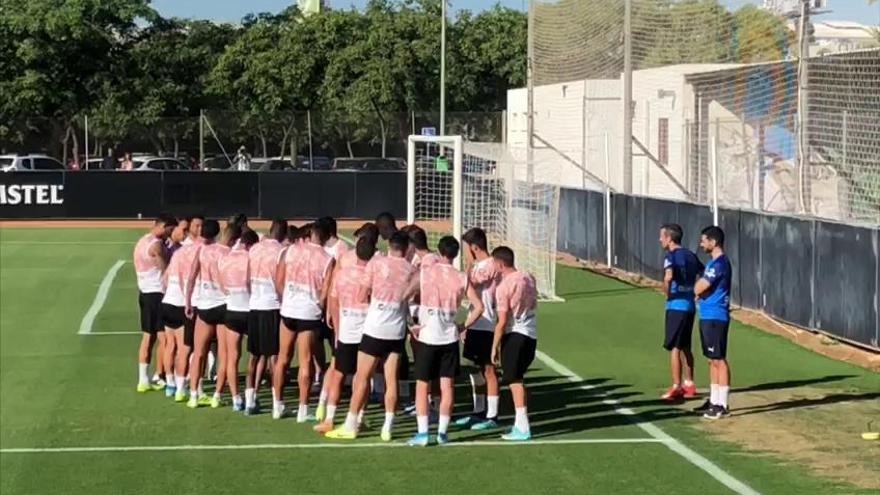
[559,254,880,374]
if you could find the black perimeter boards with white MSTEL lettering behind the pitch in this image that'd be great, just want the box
[0,171,406,219]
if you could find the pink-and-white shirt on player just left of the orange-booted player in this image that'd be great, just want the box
[281,242,333,320]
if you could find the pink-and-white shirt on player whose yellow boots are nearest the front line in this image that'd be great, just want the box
[361,256,416,340]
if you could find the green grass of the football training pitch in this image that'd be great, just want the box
[0,229,880,495]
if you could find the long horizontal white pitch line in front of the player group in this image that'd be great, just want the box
[0,438,663,454]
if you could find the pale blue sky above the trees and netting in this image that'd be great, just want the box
[152,0,880,26]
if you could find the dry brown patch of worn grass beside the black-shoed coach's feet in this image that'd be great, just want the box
[695,387,880,489]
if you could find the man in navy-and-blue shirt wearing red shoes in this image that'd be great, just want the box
[660,223,703,401]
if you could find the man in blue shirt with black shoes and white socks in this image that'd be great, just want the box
[694,226,731,419]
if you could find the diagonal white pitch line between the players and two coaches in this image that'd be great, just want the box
[535,351,759,495]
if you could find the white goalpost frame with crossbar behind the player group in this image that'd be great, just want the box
[406,135,464,245]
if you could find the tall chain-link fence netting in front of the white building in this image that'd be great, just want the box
[524,0,880,225]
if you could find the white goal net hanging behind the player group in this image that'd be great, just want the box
[407,136,559,299]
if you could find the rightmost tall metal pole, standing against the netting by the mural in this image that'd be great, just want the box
[797,0,810,213]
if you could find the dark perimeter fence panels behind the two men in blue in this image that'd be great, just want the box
[557,189,880,349]
